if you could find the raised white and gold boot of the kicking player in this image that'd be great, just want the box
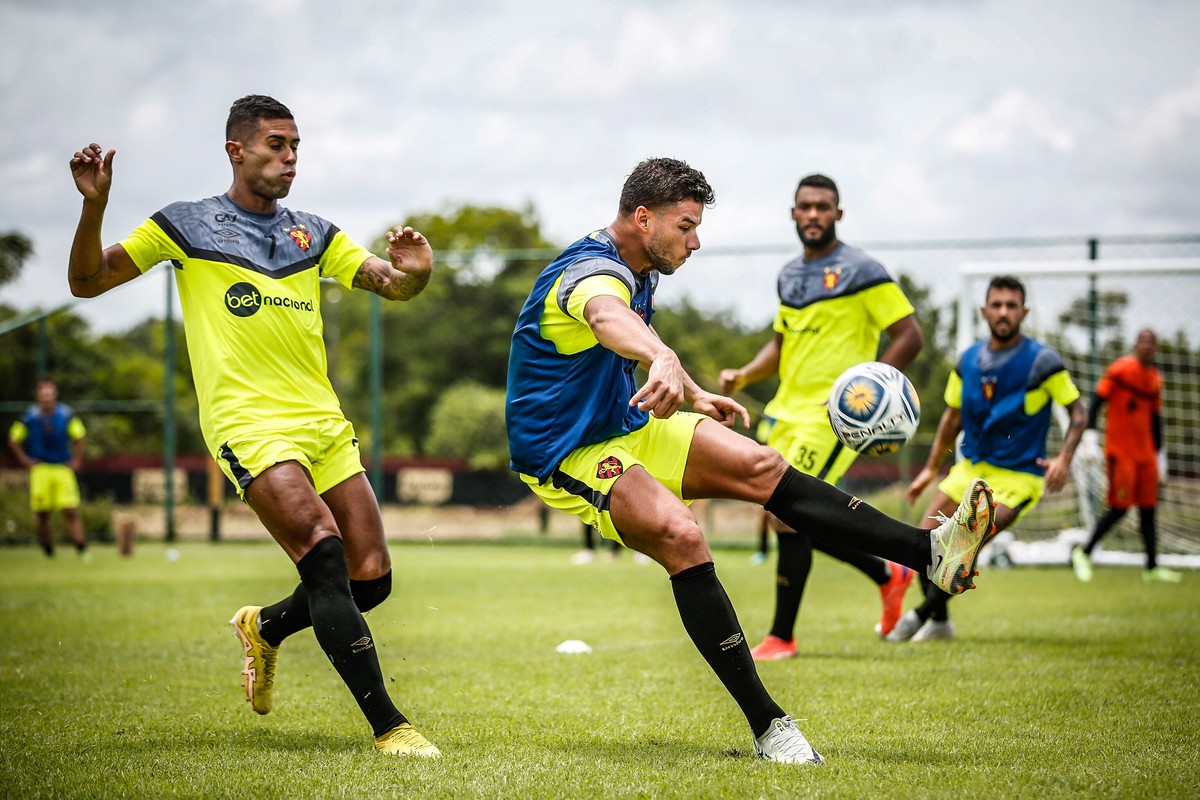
[925,477,996,595]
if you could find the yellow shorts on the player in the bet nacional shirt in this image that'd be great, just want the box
[215,417,365,499]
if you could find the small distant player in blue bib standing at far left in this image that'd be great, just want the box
[8,375,88,559]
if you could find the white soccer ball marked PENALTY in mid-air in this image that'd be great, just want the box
[829,361,920,456]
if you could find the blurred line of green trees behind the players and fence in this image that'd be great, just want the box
[0,211,1180,469]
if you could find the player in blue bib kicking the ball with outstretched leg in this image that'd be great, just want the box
[506,158,994,764]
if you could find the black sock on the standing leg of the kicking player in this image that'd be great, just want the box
[671,561,784,736]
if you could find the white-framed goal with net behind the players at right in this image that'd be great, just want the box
[956,258,1200,567]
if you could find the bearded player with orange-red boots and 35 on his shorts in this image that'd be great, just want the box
[720,175,924,661]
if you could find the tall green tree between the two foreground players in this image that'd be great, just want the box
[323,204,558,455]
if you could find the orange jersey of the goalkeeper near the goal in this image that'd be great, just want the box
[1096,355,1163,461]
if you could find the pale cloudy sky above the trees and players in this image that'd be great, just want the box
[0,0,1200,329]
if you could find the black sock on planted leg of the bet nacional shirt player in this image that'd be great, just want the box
[296,536,407,736]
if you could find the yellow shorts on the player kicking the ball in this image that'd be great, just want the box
[521,411,708,543]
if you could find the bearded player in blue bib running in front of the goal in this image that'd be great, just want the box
[902,276,1087,642]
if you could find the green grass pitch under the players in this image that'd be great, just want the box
[0,543,1200,799]
